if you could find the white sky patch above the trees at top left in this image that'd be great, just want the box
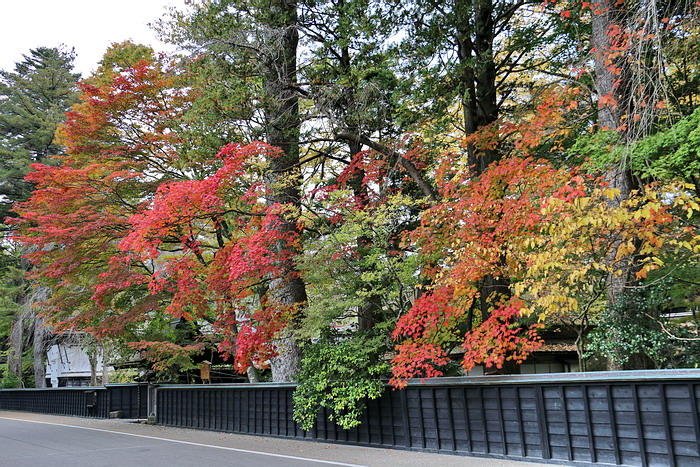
[0,0,185,77]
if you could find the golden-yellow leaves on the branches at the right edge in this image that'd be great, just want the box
[509,179,700,326]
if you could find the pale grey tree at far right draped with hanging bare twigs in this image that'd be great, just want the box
[591,1,695,369]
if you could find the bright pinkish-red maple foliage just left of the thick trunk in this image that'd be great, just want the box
[119,142,299,371]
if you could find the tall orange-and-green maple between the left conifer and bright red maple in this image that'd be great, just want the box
[14,52,204,380]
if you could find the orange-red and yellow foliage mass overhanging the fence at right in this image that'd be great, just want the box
[392,154,700,386]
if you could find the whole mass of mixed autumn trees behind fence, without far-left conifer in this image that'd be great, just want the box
[0,0,700,426]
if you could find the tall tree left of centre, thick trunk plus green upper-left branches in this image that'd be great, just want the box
[159,0,307,381]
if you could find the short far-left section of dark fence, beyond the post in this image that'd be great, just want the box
[0,384,148,418]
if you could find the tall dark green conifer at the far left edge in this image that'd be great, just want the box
[0,47,79,387]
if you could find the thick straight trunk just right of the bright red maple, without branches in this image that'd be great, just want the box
[264,0,306,381]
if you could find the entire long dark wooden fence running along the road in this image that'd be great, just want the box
[0,370,700,466]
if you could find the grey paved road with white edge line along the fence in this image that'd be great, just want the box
[0,411,551,467]
